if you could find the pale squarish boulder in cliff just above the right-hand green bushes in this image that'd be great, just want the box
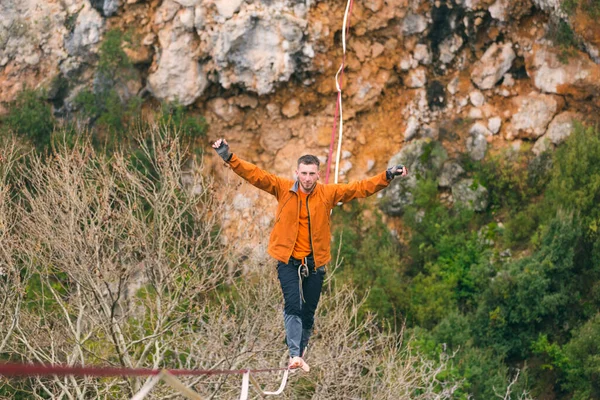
[511,92,558,139]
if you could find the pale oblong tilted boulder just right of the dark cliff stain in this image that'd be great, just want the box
[471,43,516,90]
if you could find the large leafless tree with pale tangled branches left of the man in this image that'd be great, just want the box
[2,128,232,398]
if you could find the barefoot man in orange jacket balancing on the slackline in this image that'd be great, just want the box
[212,139,408,372]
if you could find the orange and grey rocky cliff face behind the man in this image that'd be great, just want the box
[0,0,600,253]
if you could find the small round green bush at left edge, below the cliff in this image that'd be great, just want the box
[2,89,57,150]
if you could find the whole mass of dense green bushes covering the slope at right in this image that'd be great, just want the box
[390,122,600,399]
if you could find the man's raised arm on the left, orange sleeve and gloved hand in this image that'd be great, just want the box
[212,139,285,197]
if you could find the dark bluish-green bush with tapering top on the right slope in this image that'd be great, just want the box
[475,215,585,359]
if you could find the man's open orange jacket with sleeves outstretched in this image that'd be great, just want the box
[229,154,389,267]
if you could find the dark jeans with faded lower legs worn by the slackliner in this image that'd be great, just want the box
[277,256,325,357]
